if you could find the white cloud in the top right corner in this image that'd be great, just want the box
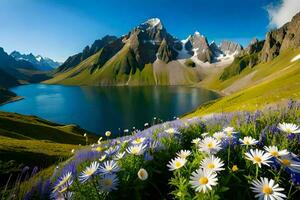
[267,0,300,28]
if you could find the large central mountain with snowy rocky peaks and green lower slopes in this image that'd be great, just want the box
[44,18,242,86]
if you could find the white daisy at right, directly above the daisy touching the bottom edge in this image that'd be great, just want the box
[245,149,272,167]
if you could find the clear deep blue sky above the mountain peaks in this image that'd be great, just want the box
[0,0,280,61]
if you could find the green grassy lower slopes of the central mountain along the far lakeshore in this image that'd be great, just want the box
[44,46,199,86]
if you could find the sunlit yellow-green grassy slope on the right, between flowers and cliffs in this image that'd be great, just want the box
[186,49,300,117]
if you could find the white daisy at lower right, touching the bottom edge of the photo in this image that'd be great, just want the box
[251,177,286,200]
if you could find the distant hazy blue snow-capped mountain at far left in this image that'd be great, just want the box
[10,51,61,71]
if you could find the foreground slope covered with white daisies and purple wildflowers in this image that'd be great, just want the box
[11,102,300,200]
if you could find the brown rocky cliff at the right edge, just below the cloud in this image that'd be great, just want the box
[261,13,300,62]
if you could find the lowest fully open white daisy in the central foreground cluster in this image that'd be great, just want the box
[190,169,218,193]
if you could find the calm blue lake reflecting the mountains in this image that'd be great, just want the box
[0,84,219,134]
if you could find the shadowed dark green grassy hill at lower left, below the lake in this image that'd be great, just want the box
[0,112,97,187]
